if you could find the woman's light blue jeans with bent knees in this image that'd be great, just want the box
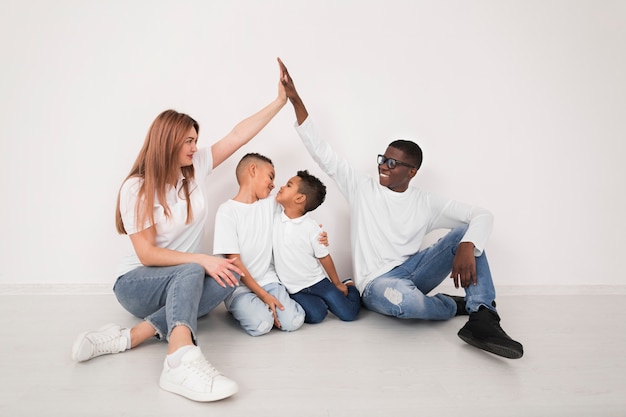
[113,263,234,342]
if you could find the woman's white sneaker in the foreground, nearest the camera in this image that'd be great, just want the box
[159,346,239,401]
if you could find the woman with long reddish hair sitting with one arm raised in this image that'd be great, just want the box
[72,63,287,401]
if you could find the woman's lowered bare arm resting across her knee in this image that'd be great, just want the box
[130,226,243,287]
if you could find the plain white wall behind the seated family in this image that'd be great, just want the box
[0,0,626,286]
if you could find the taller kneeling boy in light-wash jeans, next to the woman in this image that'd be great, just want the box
[213,153,304,336]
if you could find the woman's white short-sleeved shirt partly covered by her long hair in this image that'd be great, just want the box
[117,147,213,277]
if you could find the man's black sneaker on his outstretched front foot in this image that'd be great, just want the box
[458,306,524,359]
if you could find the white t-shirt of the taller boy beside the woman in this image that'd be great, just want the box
[213,197,278,293]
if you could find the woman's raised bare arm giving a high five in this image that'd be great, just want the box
[211,60,287,168]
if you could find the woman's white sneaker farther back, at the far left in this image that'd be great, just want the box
[72,324,128,362]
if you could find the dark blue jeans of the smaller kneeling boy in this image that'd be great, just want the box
[291,278,361,324]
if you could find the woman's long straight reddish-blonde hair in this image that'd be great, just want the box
[115,110,200,234]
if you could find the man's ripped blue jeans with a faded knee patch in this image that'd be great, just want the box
[362,225,496,320]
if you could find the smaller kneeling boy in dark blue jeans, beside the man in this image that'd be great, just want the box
[273,171,361,323]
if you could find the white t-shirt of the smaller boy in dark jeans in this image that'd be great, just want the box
[273,207,329,294]
